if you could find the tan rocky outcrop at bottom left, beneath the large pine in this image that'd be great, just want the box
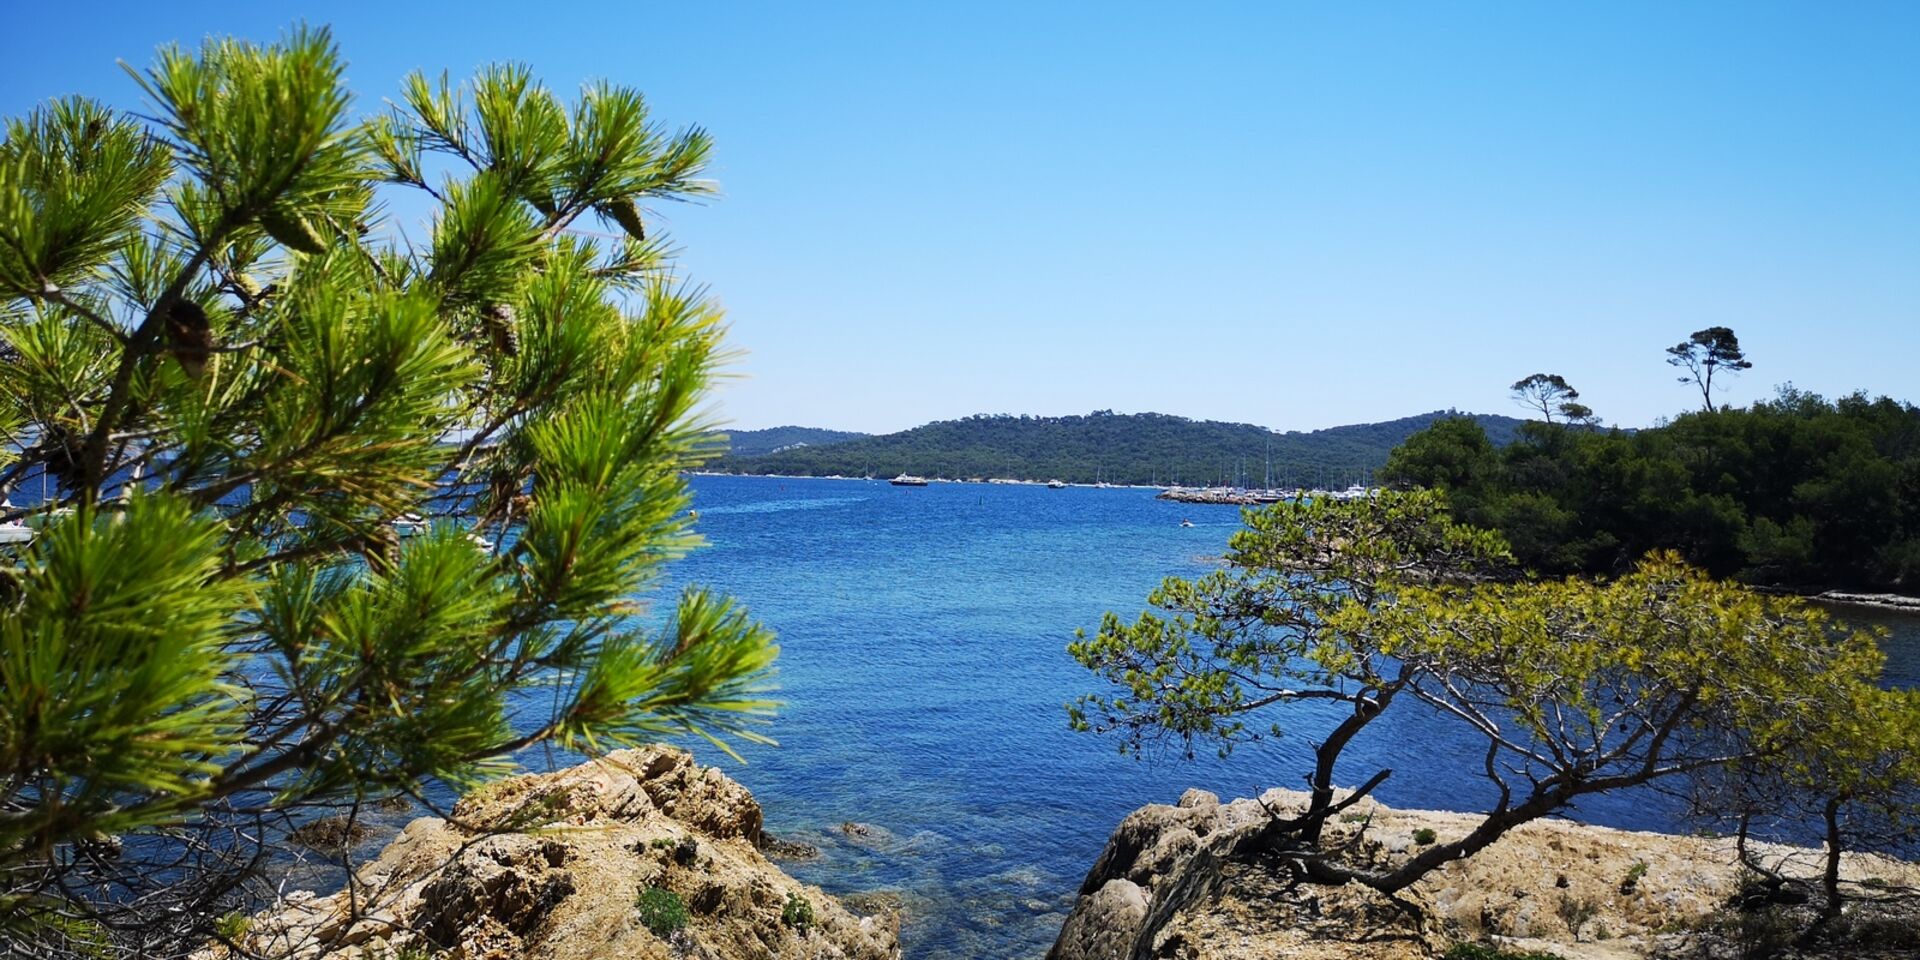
[204,747,900,960]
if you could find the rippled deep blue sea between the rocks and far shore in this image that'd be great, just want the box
[552,476,1920,960]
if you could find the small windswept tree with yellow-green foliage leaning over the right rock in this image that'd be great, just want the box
[1069,492,1882,893]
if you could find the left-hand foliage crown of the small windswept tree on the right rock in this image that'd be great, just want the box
[1068,492,1505,756]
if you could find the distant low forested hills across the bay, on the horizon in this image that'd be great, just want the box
[716,411,1521,488]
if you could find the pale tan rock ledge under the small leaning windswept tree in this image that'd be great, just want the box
[1048,789,1920,960]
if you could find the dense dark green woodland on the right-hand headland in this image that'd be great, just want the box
[1380,388,1920,591]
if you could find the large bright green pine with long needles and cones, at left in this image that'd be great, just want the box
[0,29,776,956]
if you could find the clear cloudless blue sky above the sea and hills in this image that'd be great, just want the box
[0,0,1920,432]
